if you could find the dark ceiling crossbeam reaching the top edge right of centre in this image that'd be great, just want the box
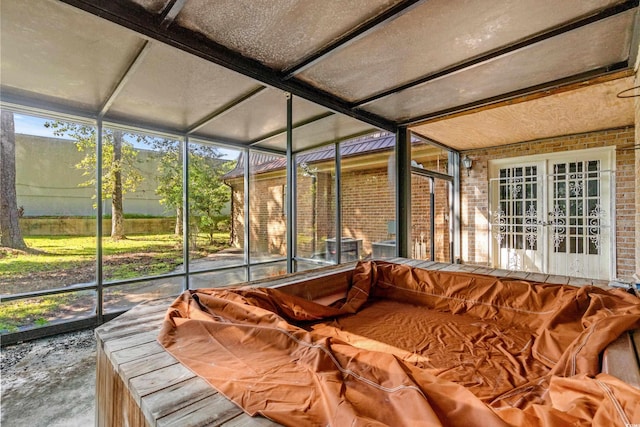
[282,0,425,80]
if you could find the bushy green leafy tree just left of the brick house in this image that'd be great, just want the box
[155,140,235,244]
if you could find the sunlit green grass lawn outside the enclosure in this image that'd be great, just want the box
[0,232,229,332]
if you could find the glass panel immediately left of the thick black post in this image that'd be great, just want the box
[340,133,396,262]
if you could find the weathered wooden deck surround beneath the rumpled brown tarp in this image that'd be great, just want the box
[95,258,640,427]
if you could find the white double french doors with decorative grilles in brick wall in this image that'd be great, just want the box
[489,149,614,279]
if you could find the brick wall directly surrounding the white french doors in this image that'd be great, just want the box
[461,127,638,280]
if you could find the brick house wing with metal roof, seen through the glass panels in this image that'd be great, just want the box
[225,134,450,261]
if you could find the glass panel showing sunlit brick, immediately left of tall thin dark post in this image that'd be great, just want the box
[249,151,287,266]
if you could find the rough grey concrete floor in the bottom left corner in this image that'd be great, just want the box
[0,330,96,427]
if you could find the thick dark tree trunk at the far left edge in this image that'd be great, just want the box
[0,110,27,249]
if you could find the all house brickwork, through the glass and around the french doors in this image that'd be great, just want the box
[227,127,639,280]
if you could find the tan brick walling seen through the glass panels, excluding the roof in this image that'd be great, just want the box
[231,152,449,261]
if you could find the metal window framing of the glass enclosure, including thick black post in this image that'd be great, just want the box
[0,88,457,345]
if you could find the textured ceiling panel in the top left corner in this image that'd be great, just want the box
[0,0,143,111]
